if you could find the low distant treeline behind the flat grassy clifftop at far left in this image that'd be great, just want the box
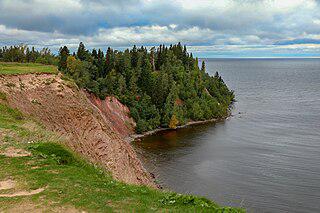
[0,45,59,65]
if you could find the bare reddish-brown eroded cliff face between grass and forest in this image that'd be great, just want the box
[0,74,155,187]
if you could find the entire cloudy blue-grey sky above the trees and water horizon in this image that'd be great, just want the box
[0,0,320,57]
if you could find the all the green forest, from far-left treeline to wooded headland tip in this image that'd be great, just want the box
[0,42,234,133]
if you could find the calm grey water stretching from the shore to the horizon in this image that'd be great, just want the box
[135,59,320,212]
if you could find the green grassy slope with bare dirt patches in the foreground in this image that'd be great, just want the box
[0,104,244,212]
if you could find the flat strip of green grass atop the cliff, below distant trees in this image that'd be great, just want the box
[0,62,58,75]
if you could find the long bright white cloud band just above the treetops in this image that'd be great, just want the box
[0,25,213,46]
